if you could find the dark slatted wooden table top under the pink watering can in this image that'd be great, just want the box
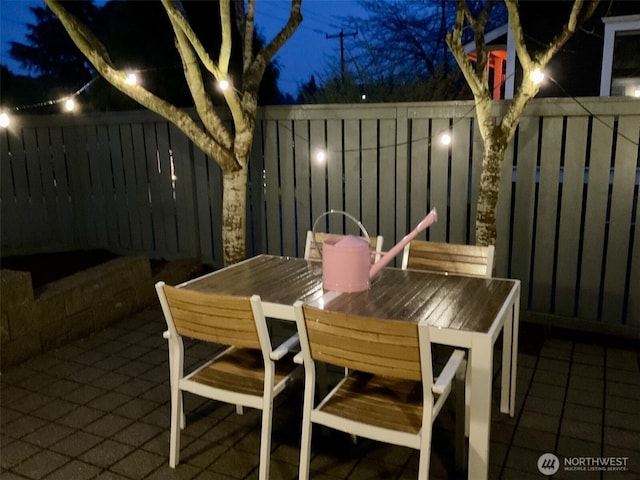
[183,255,519,332]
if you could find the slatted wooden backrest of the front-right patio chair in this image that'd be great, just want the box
[297,304,433,384]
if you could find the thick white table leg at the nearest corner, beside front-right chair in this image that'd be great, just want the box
[468,334,493,480]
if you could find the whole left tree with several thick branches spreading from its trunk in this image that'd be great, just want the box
[44,0,302,265]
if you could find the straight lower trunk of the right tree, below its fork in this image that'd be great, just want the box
[476,135,507,245]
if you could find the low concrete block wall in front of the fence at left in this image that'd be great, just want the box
[0,257,202,368]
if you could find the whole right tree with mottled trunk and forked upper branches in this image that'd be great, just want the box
[446,0,599,245]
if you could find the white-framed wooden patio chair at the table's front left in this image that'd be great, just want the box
[156,282,302,480]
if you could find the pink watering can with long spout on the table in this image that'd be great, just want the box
[313,208,438,292]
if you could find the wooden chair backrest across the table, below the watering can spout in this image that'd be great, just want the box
[402,240,494,278]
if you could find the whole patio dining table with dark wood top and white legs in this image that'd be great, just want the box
[179,255,520,480]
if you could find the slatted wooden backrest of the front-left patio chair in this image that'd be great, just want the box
[157,284,261,349]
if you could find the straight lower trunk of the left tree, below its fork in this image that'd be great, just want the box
[222,166,249,266]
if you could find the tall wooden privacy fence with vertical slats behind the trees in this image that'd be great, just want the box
[0,98,640,338]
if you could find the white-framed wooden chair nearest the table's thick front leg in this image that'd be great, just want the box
[295,302,466,480]
